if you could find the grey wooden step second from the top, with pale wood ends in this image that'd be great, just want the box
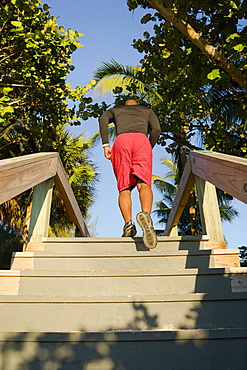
[11,249,239,271]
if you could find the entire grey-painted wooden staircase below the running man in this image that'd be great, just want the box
[0,236,247,370]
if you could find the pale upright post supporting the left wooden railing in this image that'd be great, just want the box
[28,177,53,243]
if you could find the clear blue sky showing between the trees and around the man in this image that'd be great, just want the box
[47,0,247,248]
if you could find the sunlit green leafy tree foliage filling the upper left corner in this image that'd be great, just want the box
[0,0,105,137]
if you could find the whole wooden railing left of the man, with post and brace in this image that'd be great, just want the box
[0,153,89,242]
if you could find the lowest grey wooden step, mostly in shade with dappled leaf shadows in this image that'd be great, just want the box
[0,328,247,370]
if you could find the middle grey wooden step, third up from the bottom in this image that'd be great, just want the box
[0,267,247,296]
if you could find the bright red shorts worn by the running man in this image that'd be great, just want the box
[111,132,153,191]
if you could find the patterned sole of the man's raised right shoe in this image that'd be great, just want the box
[136,212,157,249]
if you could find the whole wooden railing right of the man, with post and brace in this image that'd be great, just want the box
[164,151,247,241]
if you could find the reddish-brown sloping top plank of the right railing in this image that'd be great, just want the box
[189,152,247,203]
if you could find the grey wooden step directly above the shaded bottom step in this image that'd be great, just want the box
[0,293,247,332]
